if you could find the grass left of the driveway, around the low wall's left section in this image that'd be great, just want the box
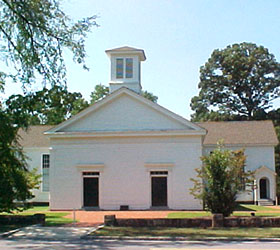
[0,206,73,232]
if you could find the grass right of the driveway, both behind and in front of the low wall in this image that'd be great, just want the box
[92,205,280,240]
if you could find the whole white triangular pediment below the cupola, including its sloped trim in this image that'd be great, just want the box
[47,88,205,133]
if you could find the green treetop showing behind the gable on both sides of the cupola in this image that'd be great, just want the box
[90,84,158,103]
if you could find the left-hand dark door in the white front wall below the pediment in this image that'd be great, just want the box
[84,177,99,207]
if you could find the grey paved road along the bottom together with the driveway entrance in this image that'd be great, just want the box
[0,226,280,250]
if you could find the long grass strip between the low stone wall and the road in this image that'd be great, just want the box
[91,227,280,239]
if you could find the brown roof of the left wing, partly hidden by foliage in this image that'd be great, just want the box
[18,125,53,148]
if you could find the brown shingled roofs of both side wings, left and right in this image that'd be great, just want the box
[19,121,278,147]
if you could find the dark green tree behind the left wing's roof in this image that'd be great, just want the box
[5,86,88,125]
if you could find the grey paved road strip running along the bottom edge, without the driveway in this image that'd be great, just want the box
[0,238,280,250]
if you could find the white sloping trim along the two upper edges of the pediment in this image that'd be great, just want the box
[45,87,206,135]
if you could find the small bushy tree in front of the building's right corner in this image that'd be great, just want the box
[191,145,253,216]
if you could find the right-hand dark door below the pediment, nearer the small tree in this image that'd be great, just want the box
[152,177,167,207]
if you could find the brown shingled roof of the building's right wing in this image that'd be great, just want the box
[197,121,278,145]
